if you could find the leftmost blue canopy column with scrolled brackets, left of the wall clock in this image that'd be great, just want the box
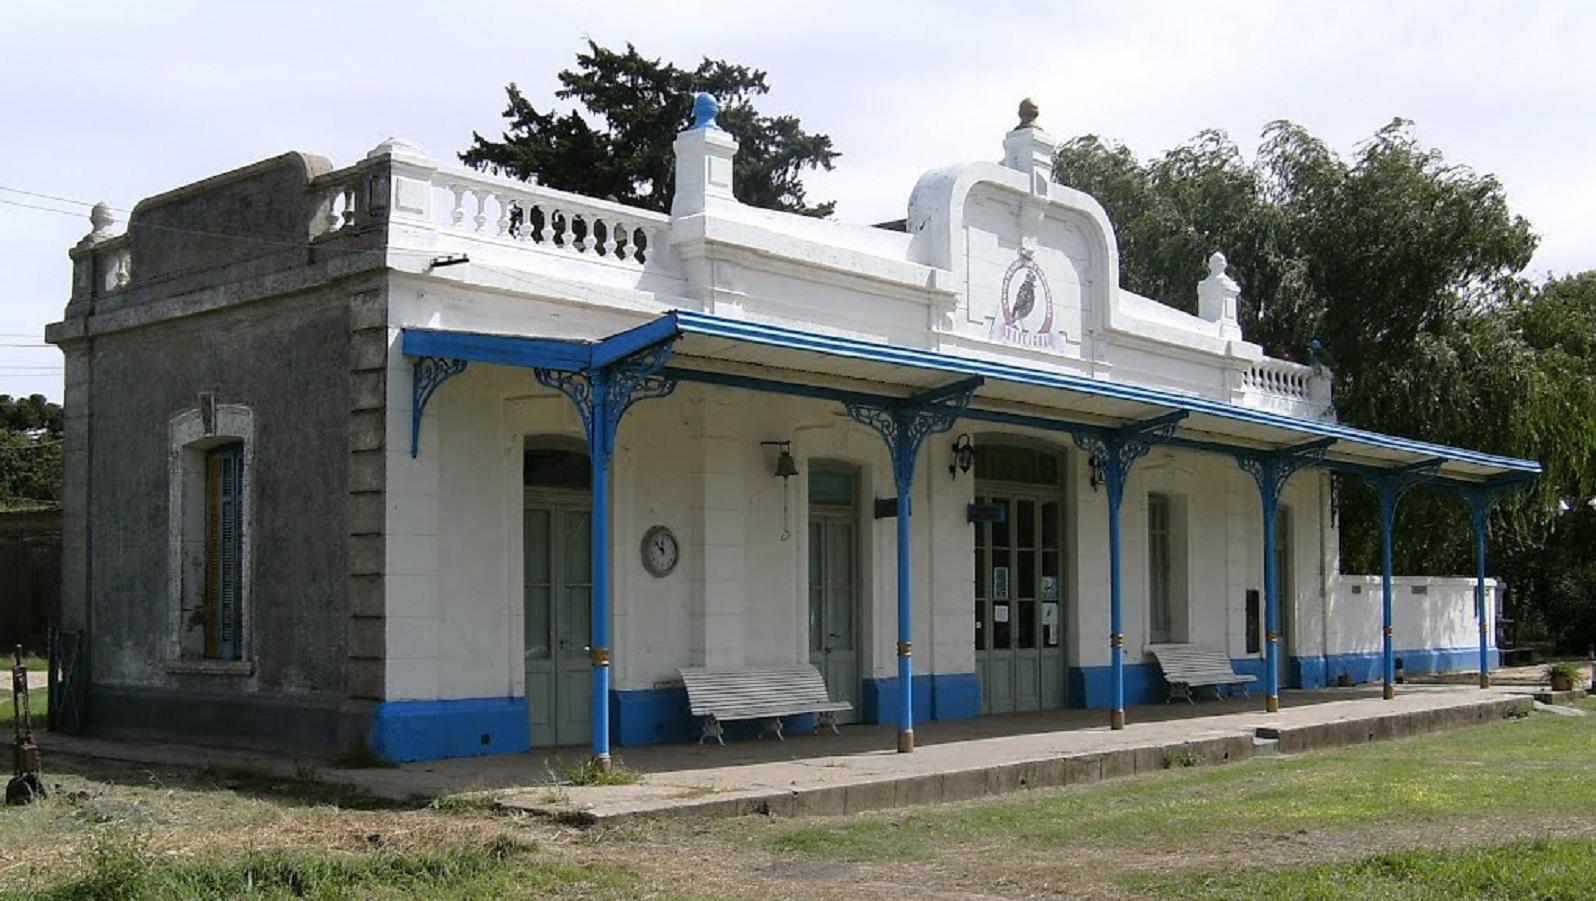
[533,341,677,772]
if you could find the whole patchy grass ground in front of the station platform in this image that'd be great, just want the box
[0,702,1596,901]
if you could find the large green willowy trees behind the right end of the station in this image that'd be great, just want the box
[1055,120,1596,649]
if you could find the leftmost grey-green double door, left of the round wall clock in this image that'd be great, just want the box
[522,498,592,748]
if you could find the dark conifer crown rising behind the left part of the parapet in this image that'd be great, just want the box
[460,40,838,215]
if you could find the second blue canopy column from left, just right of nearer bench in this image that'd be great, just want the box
[844,378,983,754]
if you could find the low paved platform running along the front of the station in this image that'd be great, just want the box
[41,686,1531,823]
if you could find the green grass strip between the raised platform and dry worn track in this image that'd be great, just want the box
[766,695,1596,861]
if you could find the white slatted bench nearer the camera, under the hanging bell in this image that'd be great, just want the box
[678,663,854,745]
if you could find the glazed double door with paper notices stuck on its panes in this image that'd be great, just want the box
[975,485,1065,713]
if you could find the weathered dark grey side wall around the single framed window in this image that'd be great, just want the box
[89,289,365,745]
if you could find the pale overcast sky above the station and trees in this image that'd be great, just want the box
[0,0,1596,399]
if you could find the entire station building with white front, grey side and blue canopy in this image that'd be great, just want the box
[51,100,1537,759]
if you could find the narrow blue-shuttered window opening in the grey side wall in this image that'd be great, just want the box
[204,442,244,660]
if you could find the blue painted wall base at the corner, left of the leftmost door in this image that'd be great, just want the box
[372,697,531,762]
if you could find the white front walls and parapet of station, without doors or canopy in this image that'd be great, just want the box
[330,103,1500,743]
